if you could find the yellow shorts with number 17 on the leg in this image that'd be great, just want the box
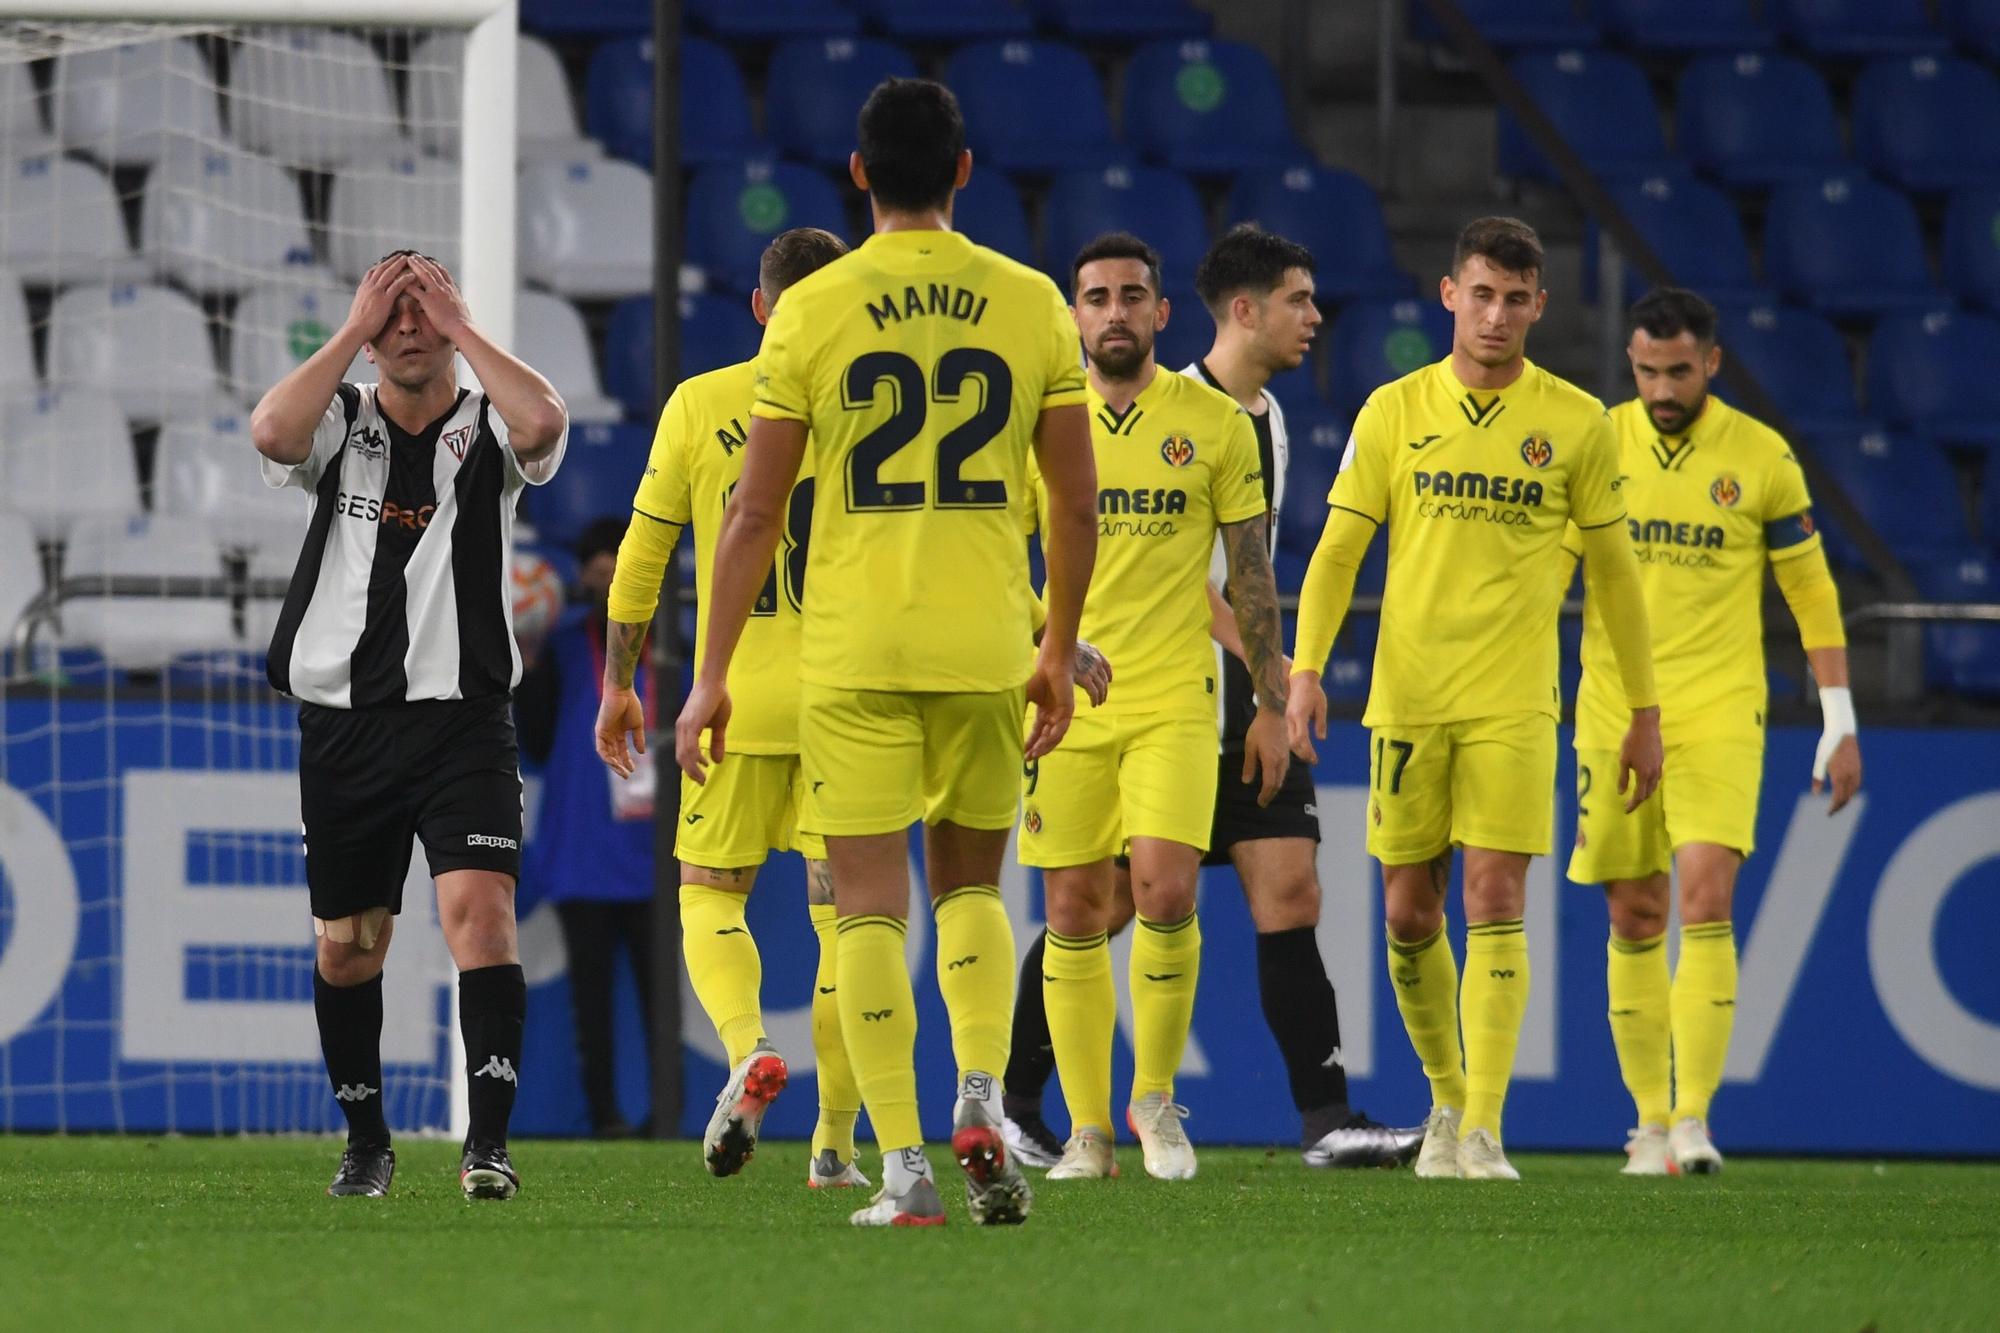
[1368,713,1556,865]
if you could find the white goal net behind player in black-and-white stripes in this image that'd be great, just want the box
[0,10,512,1133]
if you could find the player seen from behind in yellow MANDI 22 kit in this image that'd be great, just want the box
[674,78,1096,1227]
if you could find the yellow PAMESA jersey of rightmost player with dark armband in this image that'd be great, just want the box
[1568,394,1820,749]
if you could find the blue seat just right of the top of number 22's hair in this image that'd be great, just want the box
[944,42,1124,172]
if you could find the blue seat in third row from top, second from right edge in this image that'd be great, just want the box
[1764,174,1944,318]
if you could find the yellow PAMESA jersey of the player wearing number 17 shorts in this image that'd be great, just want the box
[1328,360,1624,727]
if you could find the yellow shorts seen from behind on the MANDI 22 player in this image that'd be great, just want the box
[798,685,1026,837]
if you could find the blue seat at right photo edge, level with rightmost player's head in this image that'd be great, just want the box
[1868,310,2000,448]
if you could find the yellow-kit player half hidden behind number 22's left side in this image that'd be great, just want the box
[598,226,868,1187]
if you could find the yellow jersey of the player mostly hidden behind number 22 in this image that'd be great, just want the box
[632,360,812,755]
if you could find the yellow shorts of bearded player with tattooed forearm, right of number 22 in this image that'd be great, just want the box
[1020,707,1218,867]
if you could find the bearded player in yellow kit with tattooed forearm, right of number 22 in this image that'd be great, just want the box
[1020,232,1290,1181]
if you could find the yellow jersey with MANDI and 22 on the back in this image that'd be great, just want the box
[750,230,1084,693]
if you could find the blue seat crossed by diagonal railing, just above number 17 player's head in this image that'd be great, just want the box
[1498,50,1674,180]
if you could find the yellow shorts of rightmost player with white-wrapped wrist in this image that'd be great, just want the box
[1570,737,1764,885]
